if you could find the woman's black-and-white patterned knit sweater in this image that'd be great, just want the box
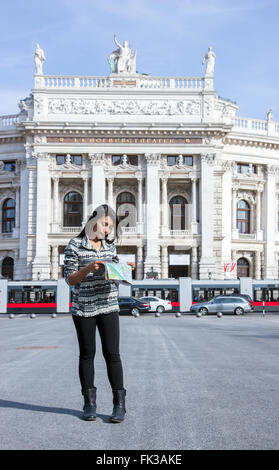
[64,236,120,317]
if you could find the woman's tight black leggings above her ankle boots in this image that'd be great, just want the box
[72,312,124,390]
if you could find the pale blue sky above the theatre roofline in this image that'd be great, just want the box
[0,0,279,121]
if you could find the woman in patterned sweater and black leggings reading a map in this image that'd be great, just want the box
[64,204,135,423]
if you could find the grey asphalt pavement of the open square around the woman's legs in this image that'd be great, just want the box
[0,313,279,450]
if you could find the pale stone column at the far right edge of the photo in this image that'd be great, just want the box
[264,165,278,279]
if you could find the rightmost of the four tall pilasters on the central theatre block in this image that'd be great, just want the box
[199,154,215,279]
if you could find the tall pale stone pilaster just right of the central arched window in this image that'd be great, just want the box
[144,154,161,278]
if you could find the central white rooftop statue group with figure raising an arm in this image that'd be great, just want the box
[108,33,136,73]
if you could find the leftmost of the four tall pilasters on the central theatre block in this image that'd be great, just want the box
[32,153,50,280]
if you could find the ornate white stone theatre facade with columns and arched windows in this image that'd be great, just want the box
[0,43,279,280]
